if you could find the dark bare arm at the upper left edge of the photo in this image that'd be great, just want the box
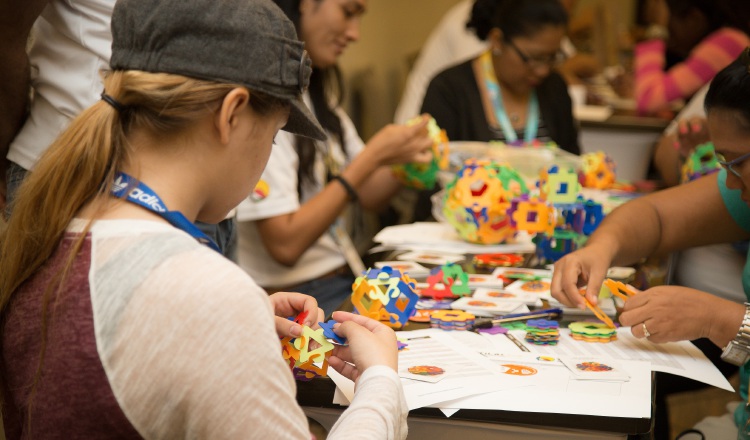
[0,0,49,208]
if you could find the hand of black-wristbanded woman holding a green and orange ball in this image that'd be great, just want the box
[365,115,433,165]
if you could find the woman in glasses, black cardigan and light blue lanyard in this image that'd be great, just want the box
[422,0,579,154]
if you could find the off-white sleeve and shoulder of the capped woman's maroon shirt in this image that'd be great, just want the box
[64,220,408,440]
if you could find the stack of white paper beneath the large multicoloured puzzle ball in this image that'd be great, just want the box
[373,222,535,254]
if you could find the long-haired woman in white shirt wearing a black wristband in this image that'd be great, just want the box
[238,0,432,313]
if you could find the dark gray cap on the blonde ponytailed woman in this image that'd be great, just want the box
[110,0,326,140]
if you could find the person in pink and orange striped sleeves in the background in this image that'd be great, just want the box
[634,0,750,114]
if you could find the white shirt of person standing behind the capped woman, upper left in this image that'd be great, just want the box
[8,0,115,170]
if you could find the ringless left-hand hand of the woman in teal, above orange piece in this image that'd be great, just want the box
[550,246,612,309]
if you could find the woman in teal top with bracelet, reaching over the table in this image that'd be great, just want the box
[552,48,750,438]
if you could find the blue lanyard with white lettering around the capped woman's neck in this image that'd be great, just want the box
[112,172,221,253]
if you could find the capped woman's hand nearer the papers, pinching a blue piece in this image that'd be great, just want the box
[328,311,398,382]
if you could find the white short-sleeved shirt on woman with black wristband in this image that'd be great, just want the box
[237,94,364,287]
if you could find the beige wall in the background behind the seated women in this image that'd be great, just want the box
[340,0,634,140]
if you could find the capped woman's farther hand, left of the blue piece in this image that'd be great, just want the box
[268,292,325,338]
